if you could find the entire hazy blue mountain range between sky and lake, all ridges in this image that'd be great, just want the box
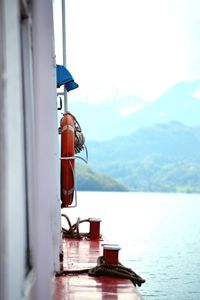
[69,80,200,193]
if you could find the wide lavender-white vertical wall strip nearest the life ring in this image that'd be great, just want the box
[32,0,61,299]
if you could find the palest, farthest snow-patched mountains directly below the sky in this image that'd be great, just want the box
[70,80,200,141]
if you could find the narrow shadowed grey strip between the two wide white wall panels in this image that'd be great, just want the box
[21,18,37,299]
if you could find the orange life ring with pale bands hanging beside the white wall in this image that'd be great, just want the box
[60,113,75,207]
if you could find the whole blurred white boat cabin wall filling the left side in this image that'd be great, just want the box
[0,0,61,300]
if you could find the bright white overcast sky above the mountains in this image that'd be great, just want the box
[55,0,200,103]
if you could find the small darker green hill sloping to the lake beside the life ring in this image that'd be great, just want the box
[76,163,128,192]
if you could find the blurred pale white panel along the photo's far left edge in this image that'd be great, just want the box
[3,0,26,300]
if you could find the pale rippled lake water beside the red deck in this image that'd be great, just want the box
[65,192,200,300]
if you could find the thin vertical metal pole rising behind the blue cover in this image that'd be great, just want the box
[62,0,68,112]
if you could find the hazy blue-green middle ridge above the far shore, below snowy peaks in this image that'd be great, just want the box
[88,122,200,193]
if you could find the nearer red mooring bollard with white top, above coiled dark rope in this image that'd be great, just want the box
[103,244,121,265]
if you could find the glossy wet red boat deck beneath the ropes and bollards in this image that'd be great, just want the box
[53,238,143,300]
